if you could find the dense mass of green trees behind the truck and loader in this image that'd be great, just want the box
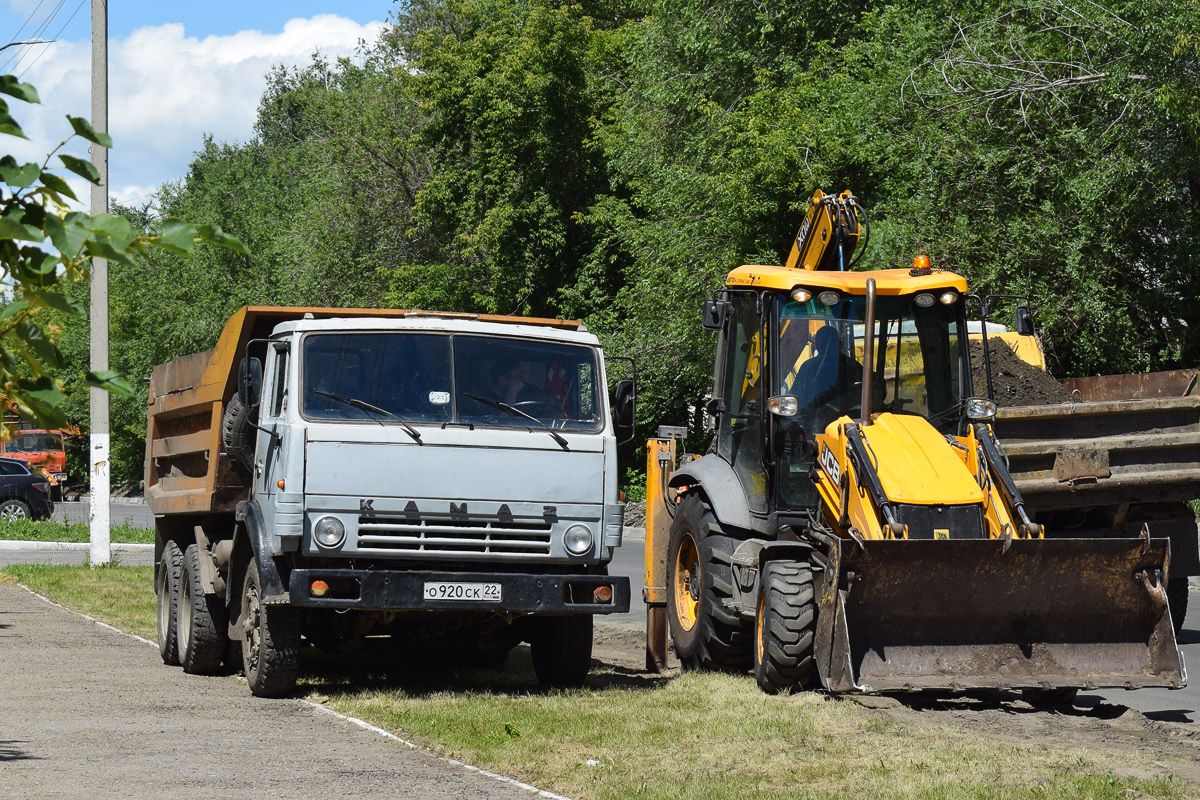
[63,0,1200,484]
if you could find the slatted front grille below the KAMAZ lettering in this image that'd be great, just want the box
[359,513,551,557]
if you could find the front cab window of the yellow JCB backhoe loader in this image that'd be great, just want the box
[775,293,962,433]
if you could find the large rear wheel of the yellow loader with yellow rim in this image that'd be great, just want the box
[667,494,752,672]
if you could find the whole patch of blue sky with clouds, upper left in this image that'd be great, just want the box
[0,0,394,204]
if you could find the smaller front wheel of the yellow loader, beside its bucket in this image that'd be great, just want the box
[754,561,817,694]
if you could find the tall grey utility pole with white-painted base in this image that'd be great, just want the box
[88,0,113,567]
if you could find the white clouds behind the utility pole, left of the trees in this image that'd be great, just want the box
[5,14,383,209]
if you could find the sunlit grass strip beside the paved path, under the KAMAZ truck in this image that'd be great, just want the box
[5,565,1193,800]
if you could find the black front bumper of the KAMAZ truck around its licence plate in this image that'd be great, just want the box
[288,570,629,614]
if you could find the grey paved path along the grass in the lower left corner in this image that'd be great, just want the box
[0,584,554,800]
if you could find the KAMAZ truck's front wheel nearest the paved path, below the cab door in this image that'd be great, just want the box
[241,560,300,697]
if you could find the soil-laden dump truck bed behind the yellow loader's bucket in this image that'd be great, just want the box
[972,339,1200,632]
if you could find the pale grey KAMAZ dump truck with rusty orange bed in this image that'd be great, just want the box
[145,307,634,697]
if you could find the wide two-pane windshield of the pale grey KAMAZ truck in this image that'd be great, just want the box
[300,332,604,432]
